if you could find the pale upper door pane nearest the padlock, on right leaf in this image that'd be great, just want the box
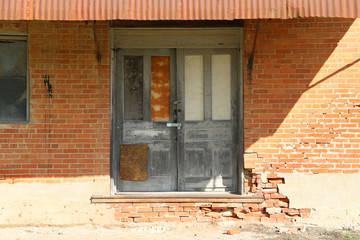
[185,55,204,121]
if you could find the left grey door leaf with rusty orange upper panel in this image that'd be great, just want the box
[115,49,177,192]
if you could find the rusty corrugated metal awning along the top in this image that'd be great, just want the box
[0,0,360,21]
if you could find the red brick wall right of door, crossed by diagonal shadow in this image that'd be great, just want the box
[244,18,360,178]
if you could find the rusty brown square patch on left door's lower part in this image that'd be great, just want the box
[120,145,149,181]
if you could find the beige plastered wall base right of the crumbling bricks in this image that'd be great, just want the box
[279,174,360,229]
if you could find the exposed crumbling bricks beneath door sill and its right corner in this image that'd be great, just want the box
[111,171,310,223]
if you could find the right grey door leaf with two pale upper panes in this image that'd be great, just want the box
[177,49,238,191]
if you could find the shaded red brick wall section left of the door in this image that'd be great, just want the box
[0,21,110,179]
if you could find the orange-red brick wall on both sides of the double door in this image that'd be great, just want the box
[0,18,360,178]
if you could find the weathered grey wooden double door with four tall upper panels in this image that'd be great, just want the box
[113,48,238,192]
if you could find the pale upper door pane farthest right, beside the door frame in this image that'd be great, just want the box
[211,55,231,120]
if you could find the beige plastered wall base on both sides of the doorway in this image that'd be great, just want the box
[0,174,360,229]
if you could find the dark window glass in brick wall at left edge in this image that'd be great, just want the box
[0,40,27,122]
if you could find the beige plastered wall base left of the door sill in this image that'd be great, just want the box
[0,178,114,226]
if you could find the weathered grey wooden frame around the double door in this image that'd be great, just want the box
[110,27,244,195]
